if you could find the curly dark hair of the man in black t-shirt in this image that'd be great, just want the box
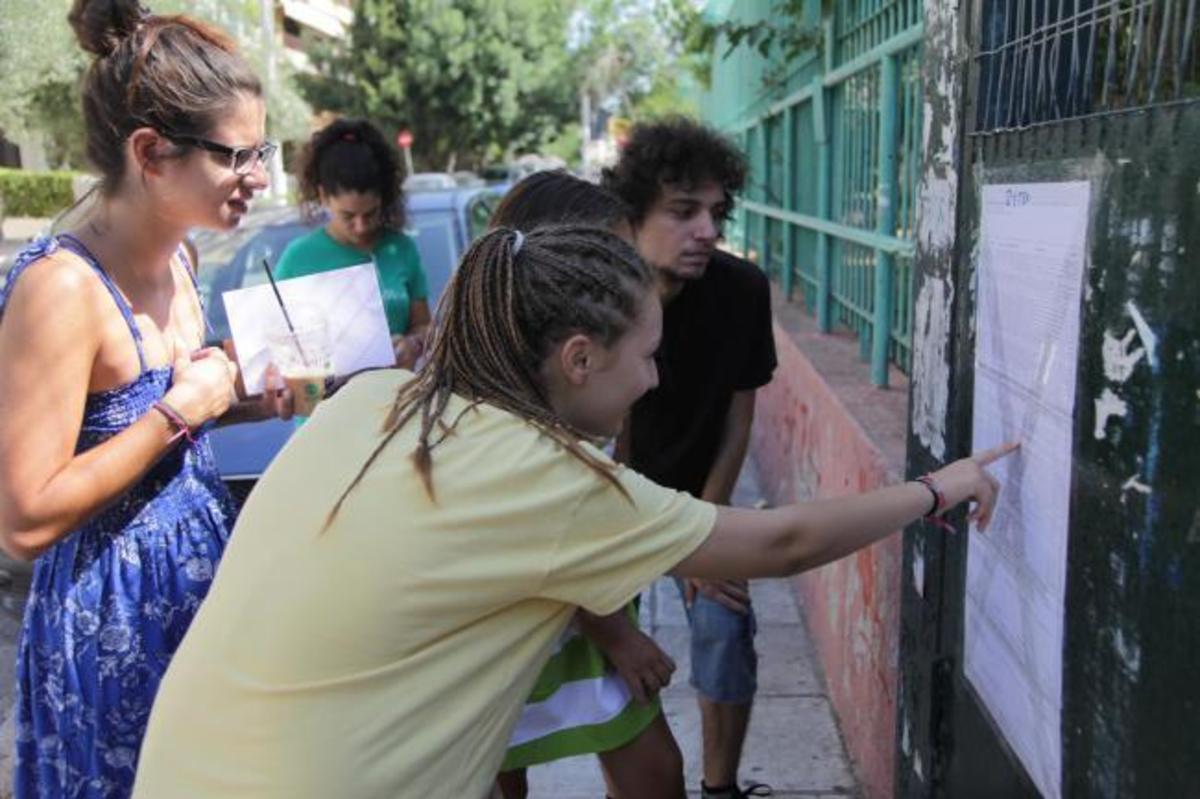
[601,116,746,222]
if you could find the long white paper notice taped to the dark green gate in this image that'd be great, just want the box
[964,181,1091,799]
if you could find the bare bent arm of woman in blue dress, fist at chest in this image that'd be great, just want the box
[0,254,233,560]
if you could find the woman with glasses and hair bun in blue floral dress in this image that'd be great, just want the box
[0,0,274,798]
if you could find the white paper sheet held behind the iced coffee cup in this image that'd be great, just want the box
[222,264,396,395]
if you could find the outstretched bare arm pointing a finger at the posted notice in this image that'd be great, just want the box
[671,444,1016,578]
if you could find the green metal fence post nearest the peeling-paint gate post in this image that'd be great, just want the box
[871,55,900,389]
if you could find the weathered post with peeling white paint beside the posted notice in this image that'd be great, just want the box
[893,0,970,798]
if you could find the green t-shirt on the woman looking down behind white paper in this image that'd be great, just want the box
[275,228,430,336]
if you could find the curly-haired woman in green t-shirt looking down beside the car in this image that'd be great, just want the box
[276,119,430,368]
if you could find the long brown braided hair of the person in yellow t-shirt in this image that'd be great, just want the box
[326,226,654,524]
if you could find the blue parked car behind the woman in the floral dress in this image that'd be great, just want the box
[193,186,506,504]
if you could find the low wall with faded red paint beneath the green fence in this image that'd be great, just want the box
[751,305,907,799]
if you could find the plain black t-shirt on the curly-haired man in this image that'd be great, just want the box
[630,251,775,497]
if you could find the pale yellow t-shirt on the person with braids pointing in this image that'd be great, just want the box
[134,371,715,799]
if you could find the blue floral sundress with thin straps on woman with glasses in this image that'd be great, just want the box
[0,236,235,799]
